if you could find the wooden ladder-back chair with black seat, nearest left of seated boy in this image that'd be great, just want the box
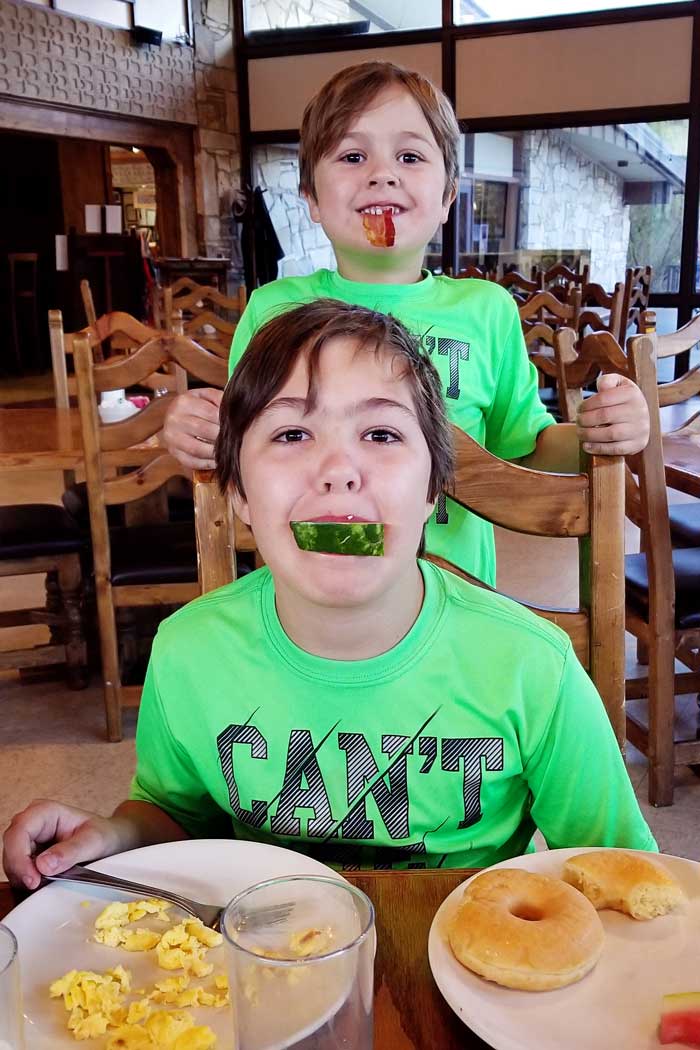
[72,332,227,740]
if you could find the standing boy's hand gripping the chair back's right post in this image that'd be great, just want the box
[576,373,649,456]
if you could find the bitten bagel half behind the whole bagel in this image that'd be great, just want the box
[563,849,683,919]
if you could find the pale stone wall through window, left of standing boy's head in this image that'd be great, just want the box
[253,146,336,277]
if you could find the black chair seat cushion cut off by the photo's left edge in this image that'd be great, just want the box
[0,503,85,560]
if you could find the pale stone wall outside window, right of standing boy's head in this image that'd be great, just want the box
[517,130,630,290]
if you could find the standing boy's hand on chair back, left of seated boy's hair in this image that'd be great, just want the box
[163,386,224,470]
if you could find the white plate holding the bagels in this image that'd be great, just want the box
[428,848,700,1050]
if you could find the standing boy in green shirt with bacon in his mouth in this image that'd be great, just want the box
[165,62,649,585]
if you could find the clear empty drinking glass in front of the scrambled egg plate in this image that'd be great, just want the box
[221,876,375,1050]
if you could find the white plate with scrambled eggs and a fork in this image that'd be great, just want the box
[3,839,341,1050]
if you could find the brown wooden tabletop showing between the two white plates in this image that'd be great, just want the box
[0,868,489,1050]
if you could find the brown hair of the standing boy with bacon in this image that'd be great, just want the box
[299,62,460,201]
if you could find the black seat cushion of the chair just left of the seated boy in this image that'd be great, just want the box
[109,523,197,585]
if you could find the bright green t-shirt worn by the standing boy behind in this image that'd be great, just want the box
[229,270,554,586]
